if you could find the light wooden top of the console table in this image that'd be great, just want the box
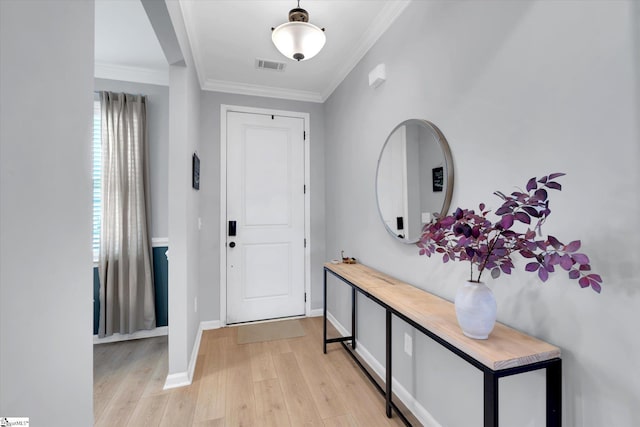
[325,263,560,371]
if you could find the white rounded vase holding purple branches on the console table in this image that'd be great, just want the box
[455,282,497,340]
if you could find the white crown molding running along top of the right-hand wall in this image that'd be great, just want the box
[322,0,412,102]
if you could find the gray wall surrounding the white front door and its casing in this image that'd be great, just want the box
[199,92,324,321]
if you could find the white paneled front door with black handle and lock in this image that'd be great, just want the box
[225,111,305,324]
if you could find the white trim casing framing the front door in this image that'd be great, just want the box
[220,104,313,326]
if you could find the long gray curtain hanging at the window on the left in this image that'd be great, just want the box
[98,92,156,337]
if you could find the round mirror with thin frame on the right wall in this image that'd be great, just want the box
[376,119,453,243]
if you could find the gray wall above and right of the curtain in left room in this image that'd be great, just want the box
[94,79,169,238]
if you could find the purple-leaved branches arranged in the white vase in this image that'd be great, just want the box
[417,173,602,293]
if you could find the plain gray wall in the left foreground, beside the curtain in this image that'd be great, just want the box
[0,0,94,427]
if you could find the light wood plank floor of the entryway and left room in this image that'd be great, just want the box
[94,317,420,427]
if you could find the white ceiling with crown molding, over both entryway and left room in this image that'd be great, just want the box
[95,0,409,102]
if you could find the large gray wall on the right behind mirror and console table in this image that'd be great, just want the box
[325,0,640,427]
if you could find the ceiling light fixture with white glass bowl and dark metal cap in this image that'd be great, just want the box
[271,0,327,61]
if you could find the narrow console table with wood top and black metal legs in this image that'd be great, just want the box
[323,263,562,427]
